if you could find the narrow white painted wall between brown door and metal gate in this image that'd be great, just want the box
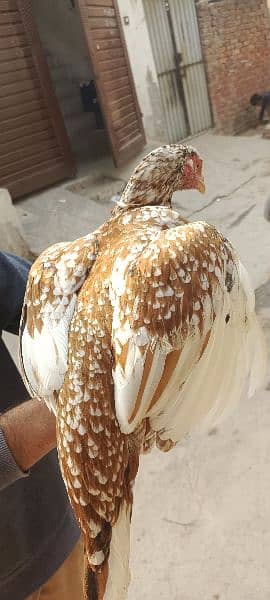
[118,0,167,142]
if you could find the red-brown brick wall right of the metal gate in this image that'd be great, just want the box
[197,0,270,133]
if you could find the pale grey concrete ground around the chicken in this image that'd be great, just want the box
[9,133,270,600]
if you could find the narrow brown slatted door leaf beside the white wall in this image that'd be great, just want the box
[77,0,145,166]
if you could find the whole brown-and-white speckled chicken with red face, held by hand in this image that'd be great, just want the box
[21,145,266,600]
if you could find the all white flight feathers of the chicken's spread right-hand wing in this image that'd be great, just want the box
[114,250,266,442]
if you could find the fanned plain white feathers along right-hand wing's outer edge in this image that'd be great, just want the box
[151,266,266,442]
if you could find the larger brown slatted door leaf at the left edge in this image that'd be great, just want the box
[0,0,75,198]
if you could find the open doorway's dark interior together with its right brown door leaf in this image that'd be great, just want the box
[33,0,145,171]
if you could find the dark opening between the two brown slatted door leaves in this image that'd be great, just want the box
[33,0,110,164]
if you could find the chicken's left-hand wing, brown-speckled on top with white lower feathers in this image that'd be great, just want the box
[20,234,98,410]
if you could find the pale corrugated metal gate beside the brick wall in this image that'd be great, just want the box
[144,0,212,142]
